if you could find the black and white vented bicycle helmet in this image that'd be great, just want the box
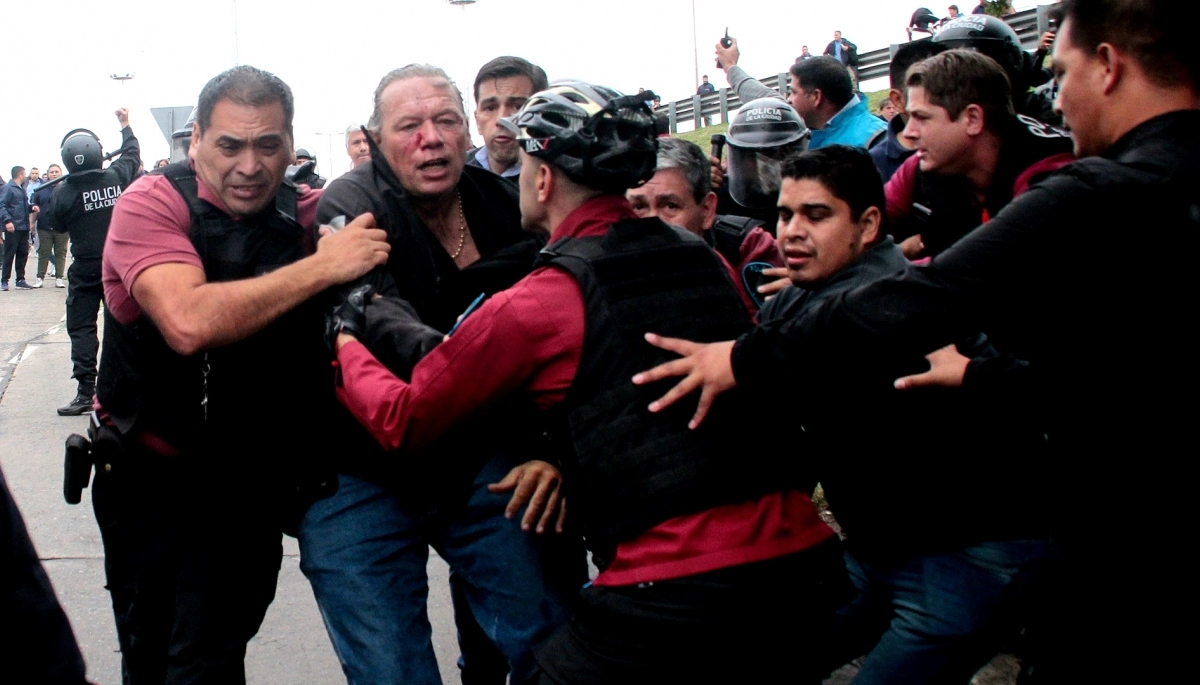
[500,80,659,193]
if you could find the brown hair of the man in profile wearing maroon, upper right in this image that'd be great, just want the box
[905,49,1016,131]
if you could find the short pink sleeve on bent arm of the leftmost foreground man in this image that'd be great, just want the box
[103,176,204,323]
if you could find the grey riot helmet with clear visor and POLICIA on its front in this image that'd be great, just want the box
[725,97,809,209]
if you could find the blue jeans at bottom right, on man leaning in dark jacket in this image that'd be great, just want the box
[835,540,1051,685]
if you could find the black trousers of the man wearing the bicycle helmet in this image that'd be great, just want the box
[534,540,853,685]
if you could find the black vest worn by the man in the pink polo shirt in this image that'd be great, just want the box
[97,162,335,453]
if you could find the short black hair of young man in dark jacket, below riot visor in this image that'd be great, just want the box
[780,145,887,229]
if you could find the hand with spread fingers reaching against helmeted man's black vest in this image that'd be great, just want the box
[634,334,738,428]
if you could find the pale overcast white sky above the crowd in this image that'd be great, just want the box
[0,0,1038,179]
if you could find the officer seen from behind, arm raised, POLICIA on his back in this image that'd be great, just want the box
[49,107,142,416]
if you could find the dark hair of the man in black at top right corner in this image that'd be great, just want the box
[1060,0,1200,90]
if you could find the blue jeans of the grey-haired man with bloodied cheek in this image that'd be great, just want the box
[298,457,587,685]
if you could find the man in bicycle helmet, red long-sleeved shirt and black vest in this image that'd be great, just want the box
[335,82,847,684]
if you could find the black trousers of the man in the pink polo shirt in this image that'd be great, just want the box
[91,428,283,685]
